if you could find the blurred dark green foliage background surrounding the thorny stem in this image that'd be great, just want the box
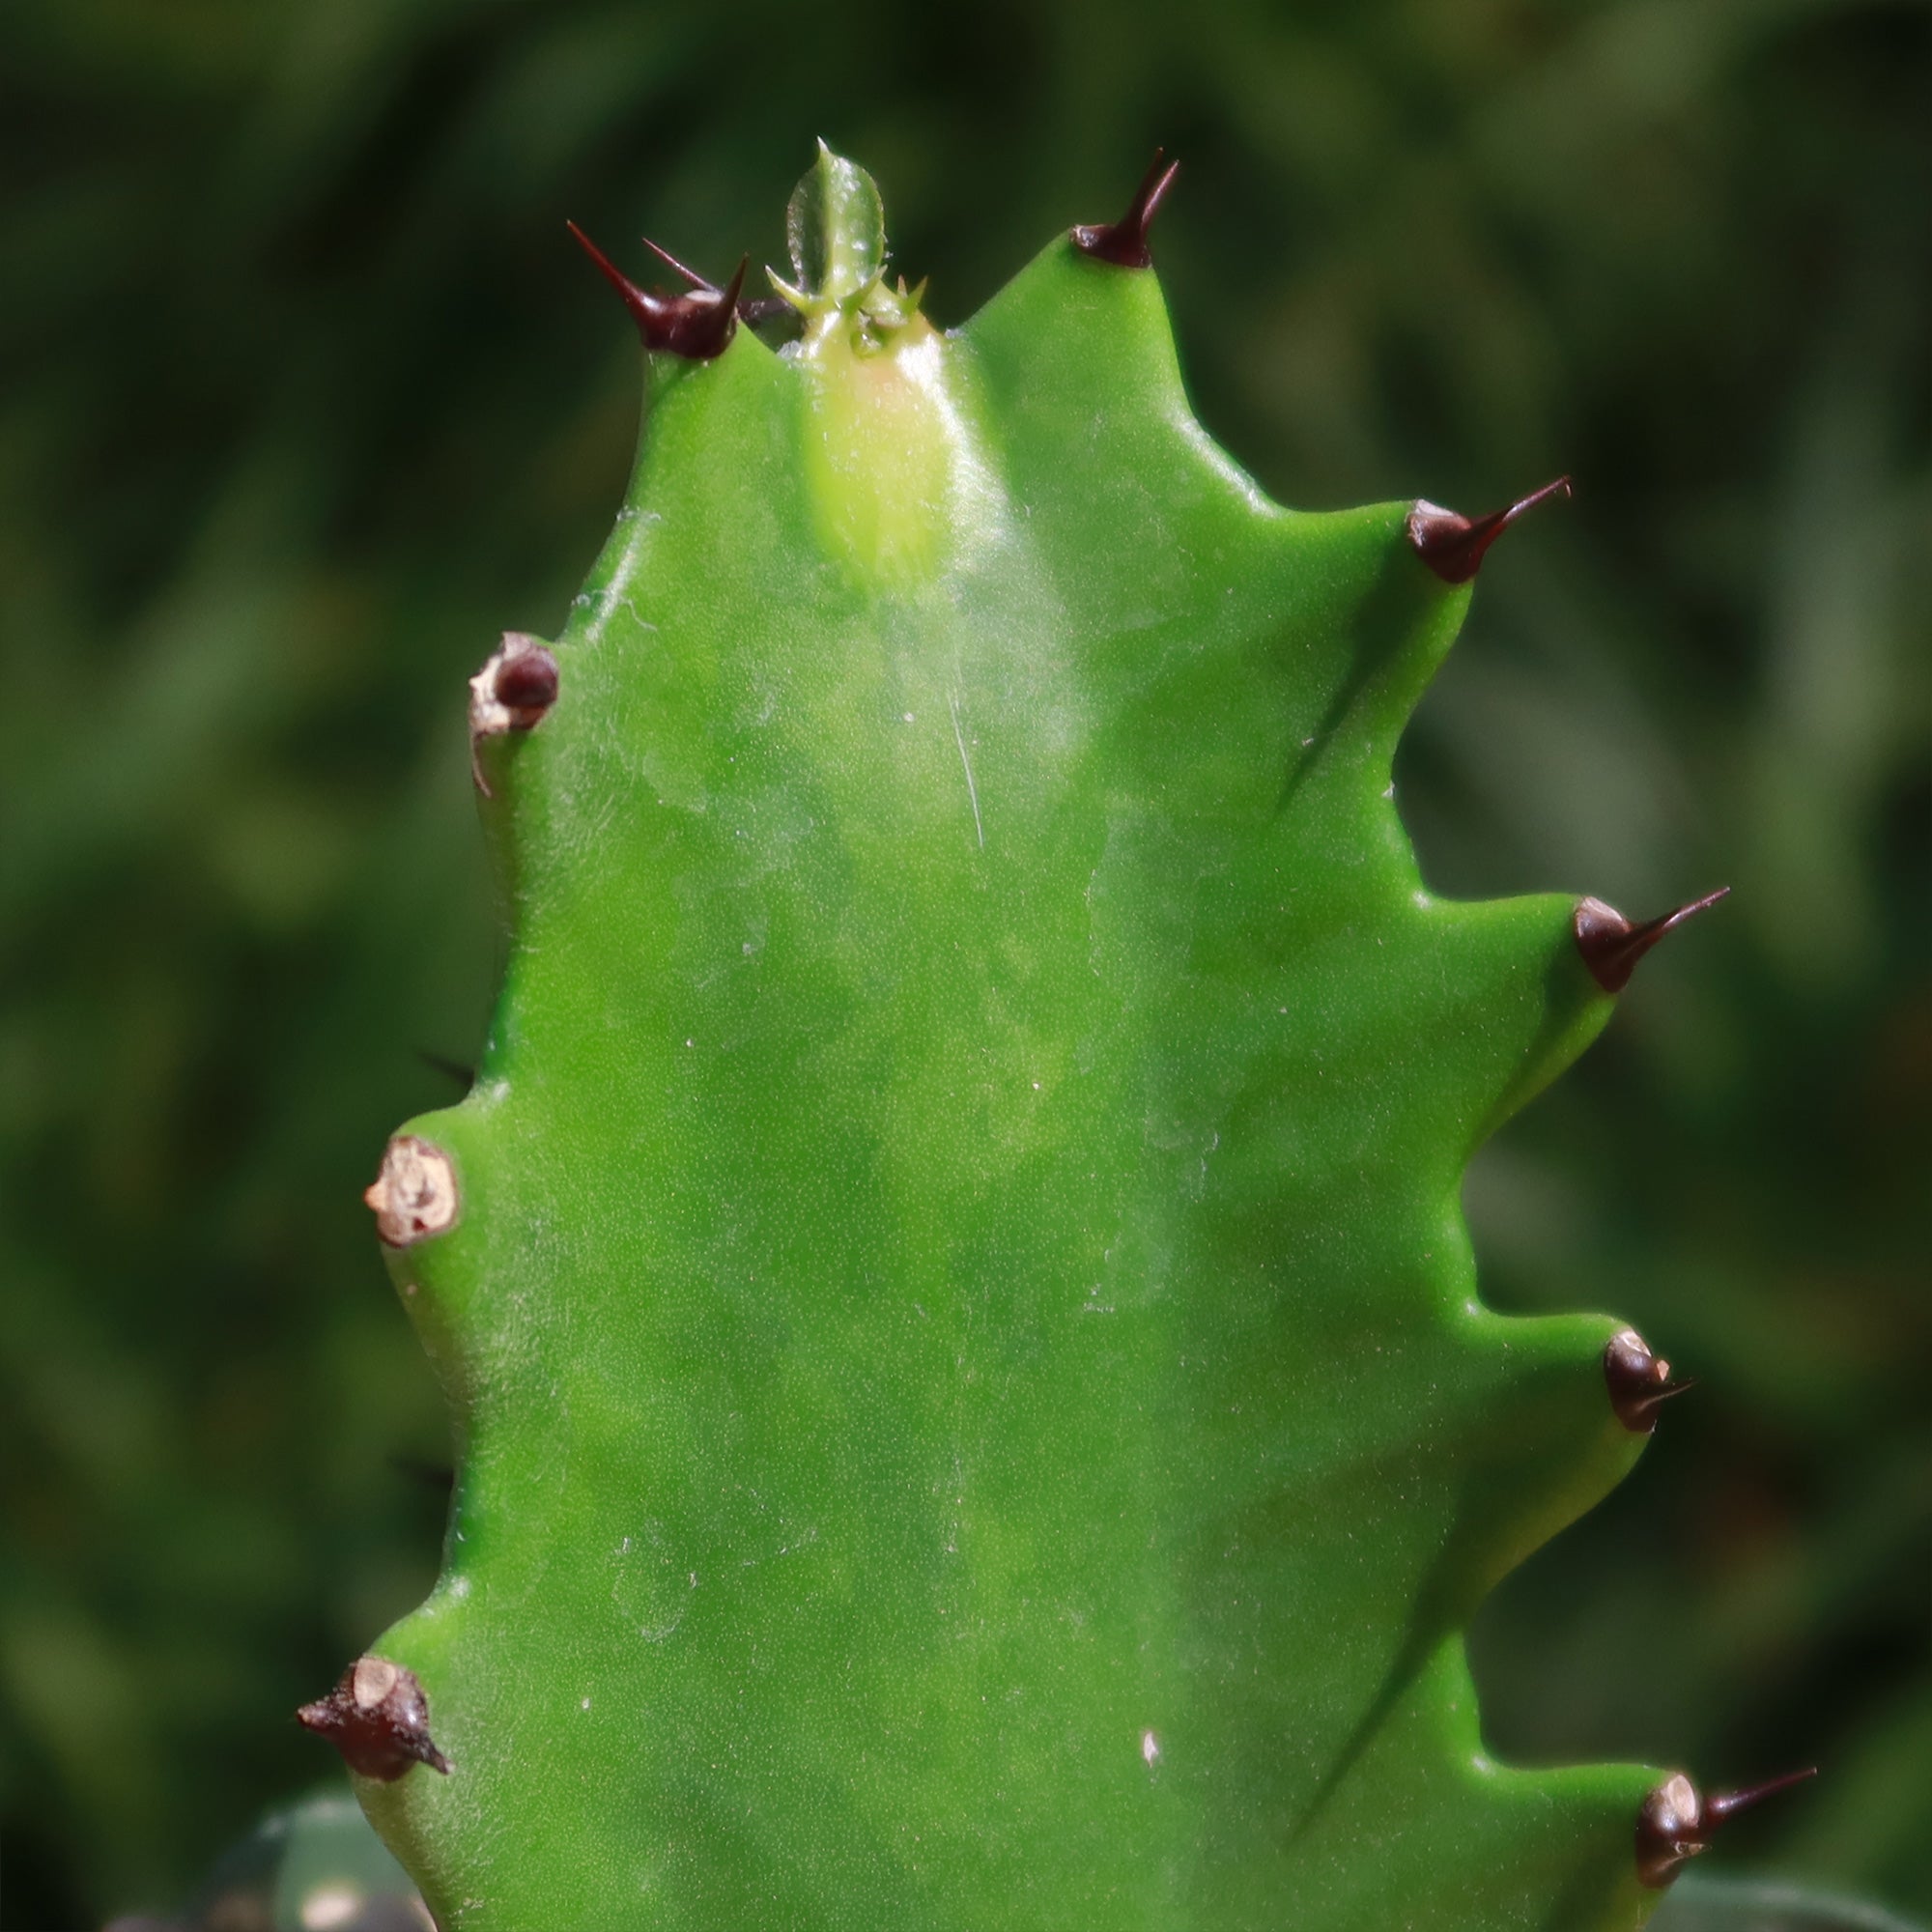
[0,0,1932,1932]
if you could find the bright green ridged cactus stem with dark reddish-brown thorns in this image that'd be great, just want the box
[303,151,1793,1932]
